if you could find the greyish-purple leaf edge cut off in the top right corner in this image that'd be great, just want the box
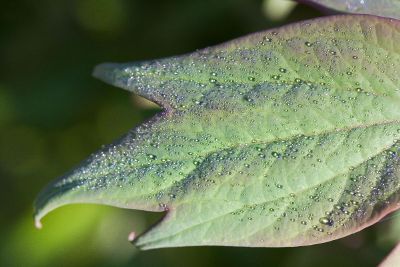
[297,0,400,19]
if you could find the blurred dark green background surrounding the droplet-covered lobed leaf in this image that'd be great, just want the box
[0,0,400,267]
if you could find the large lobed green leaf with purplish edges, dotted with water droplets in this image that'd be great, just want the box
[32,16,400,249]
